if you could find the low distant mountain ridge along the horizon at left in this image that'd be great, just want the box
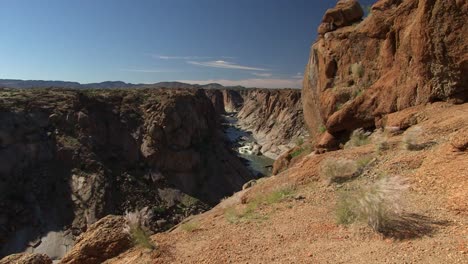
[0,79,249,89]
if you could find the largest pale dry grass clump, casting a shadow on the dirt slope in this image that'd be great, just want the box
[336,176,408,232]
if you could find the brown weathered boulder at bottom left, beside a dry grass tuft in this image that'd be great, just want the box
[60,215,132,264]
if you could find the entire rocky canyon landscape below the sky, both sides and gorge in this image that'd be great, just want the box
[0,0,468,264]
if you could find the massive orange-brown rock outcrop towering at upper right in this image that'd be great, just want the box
[303,0,468,147]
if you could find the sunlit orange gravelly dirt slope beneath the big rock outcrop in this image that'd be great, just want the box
[107,103,468,263]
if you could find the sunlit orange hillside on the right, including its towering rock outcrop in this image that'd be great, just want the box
[58,0,468,264]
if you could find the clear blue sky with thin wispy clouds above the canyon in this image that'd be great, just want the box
[0,0,372,87]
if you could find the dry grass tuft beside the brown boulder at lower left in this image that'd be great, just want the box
[123,210,156,249]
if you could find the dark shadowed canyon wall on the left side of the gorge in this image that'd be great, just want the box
[0,89,252,257]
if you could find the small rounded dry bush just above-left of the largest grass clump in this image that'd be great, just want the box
[320,158,359,183]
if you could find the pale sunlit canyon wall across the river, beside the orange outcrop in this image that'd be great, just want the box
[237,89,307,159]
